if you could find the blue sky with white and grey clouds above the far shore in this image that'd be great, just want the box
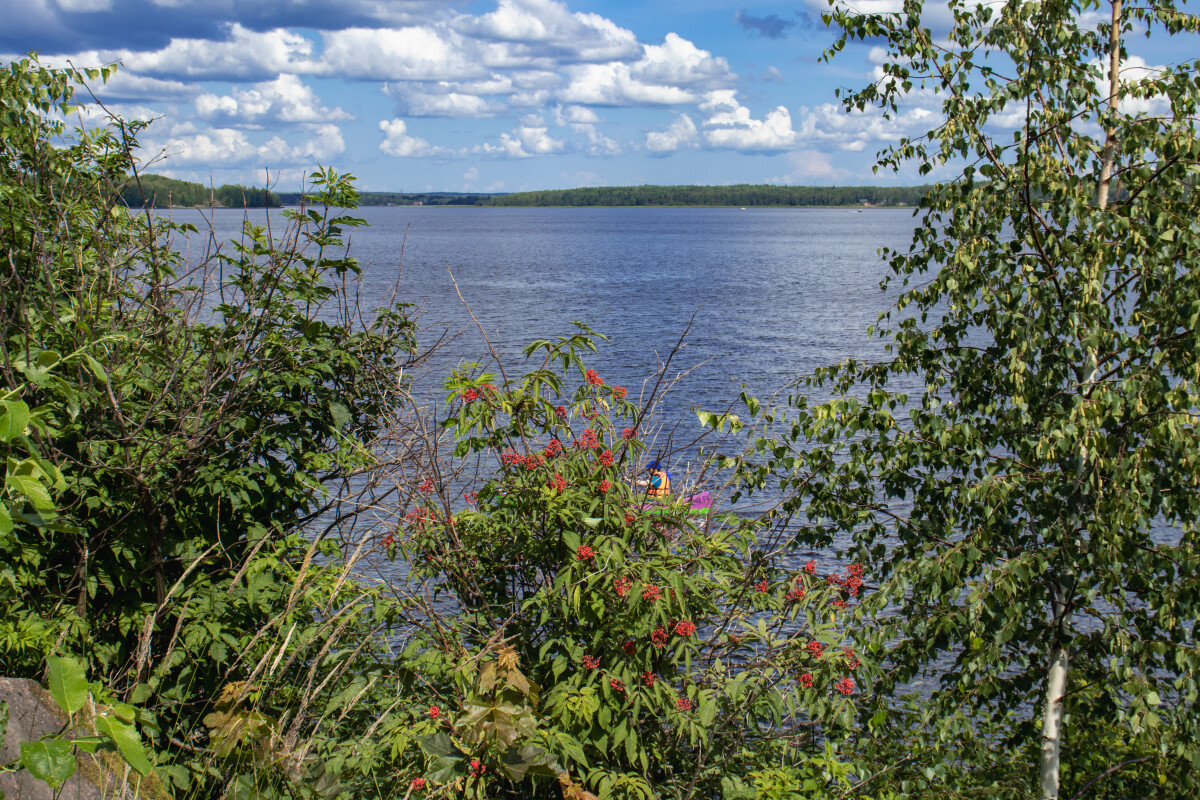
[0,0,1190,192]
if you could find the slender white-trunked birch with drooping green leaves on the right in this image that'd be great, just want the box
[720,0,1200,798]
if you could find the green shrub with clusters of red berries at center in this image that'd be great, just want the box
[360,343,859,798]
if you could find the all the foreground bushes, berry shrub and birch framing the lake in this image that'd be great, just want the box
[0,0,1200,798]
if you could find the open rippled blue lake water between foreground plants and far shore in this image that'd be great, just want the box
[164,206,913,425]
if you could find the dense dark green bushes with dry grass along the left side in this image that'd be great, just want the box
[0,59,427,792]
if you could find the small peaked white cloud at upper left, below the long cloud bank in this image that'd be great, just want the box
[196,76,353,126]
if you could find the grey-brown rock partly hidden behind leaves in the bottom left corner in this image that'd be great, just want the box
[0,678,124,800]
